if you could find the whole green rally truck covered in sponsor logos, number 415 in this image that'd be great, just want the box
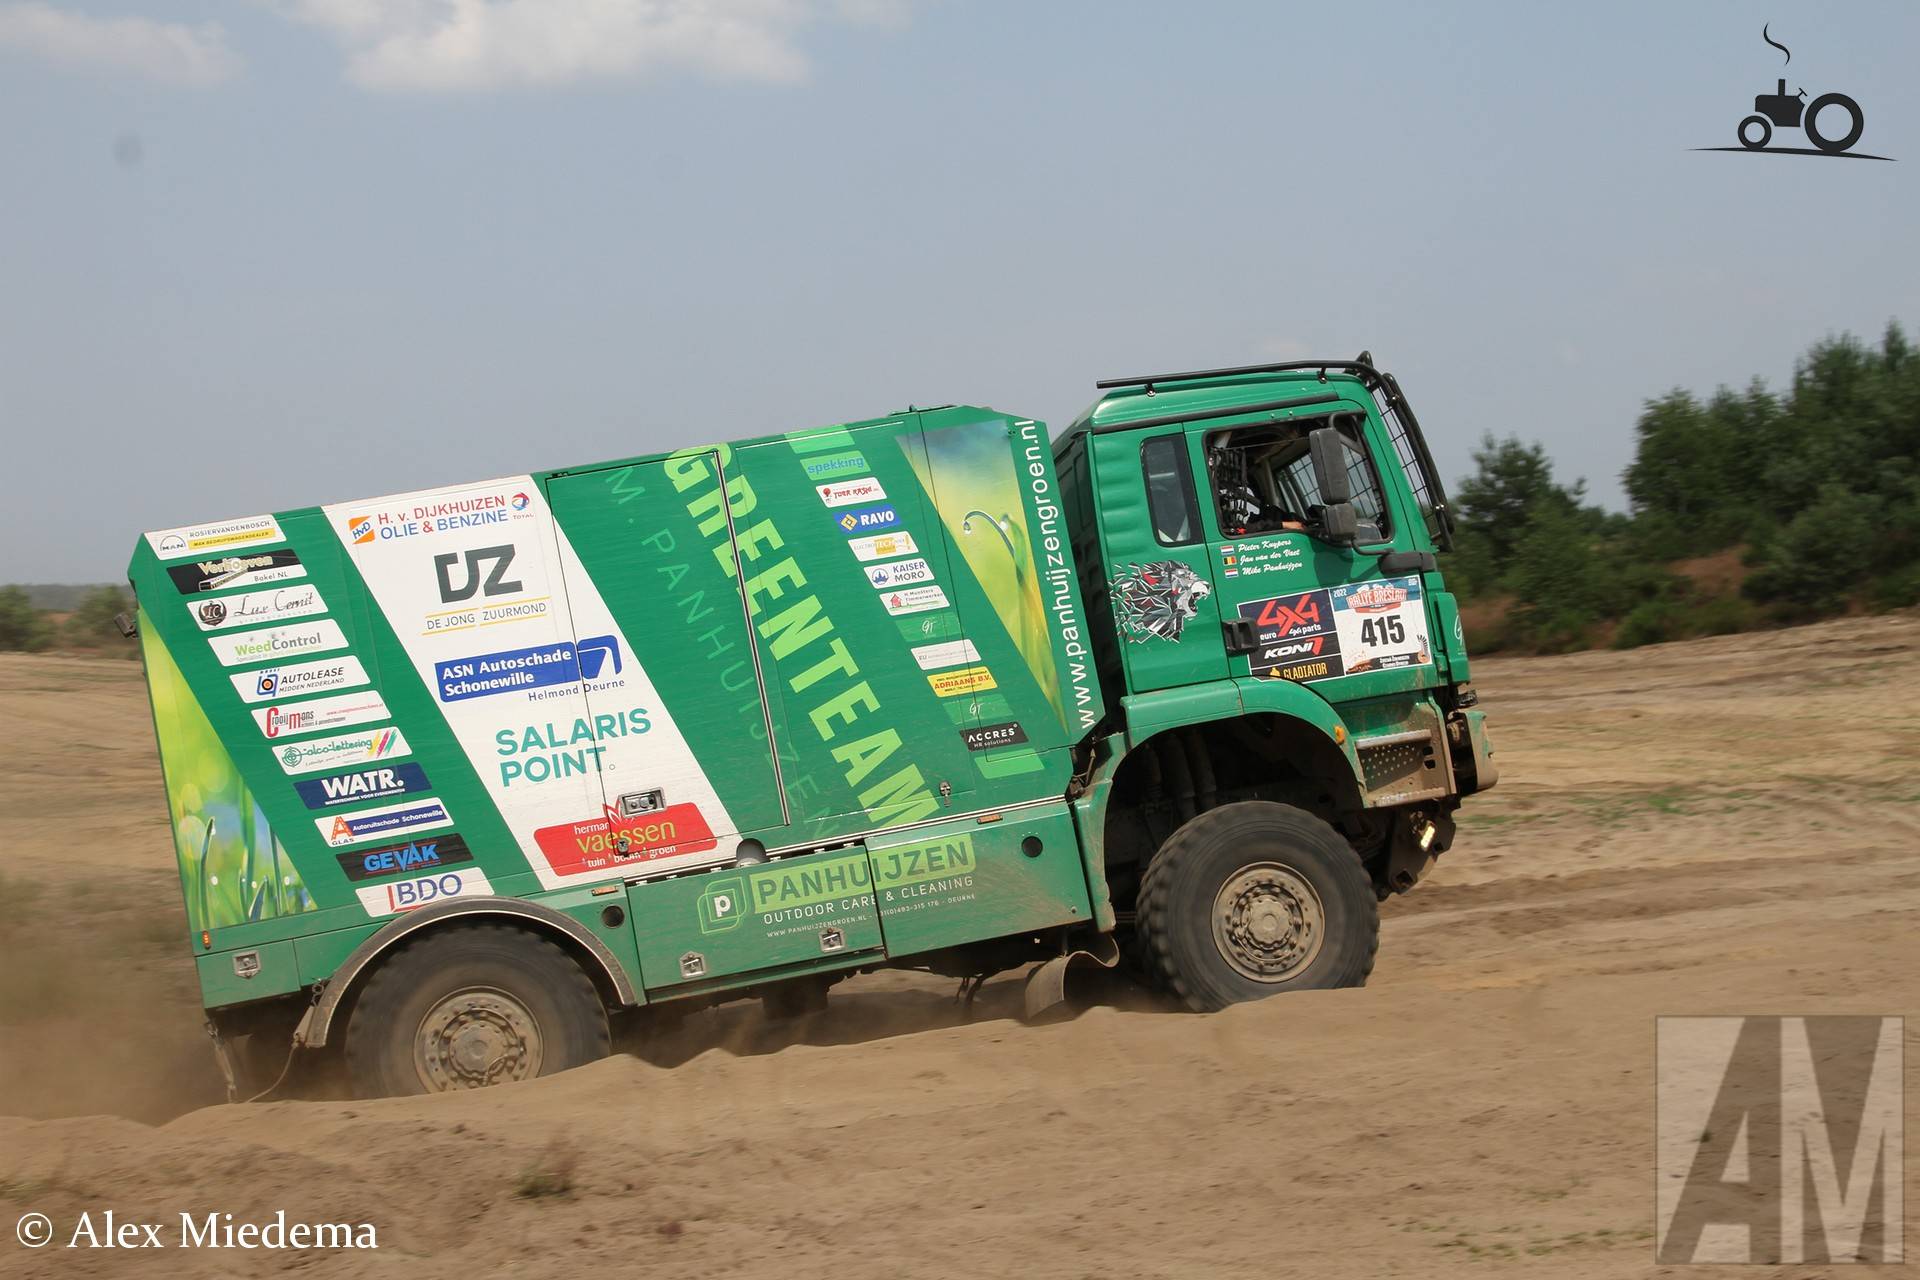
[131,355,1496,1096]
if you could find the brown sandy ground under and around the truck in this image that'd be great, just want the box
[0,616,1920,1278]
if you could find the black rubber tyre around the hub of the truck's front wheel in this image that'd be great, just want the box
[1137,800,1380,1013]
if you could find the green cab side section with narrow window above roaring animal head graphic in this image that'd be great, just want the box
[1092,424,1229,693]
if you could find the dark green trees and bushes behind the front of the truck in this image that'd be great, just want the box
[1442,322,1920,652]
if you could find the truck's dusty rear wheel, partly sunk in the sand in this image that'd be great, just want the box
[346,925,612,1098]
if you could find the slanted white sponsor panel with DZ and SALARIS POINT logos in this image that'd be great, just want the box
[326,476,737,889]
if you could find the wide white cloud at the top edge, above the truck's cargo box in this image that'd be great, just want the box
[278,0,904,90]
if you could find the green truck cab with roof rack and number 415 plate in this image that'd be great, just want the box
[1056,355,1498,948]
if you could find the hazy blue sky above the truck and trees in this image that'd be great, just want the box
[0,0,1920,581]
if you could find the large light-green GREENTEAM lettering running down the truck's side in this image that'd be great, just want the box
[666,443,939,825]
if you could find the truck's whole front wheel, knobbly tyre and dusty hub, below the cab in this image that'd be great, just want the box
[1137,802,1380,1013]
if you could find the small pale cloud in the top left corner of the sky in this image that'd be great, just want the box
[0,0,240,88]
